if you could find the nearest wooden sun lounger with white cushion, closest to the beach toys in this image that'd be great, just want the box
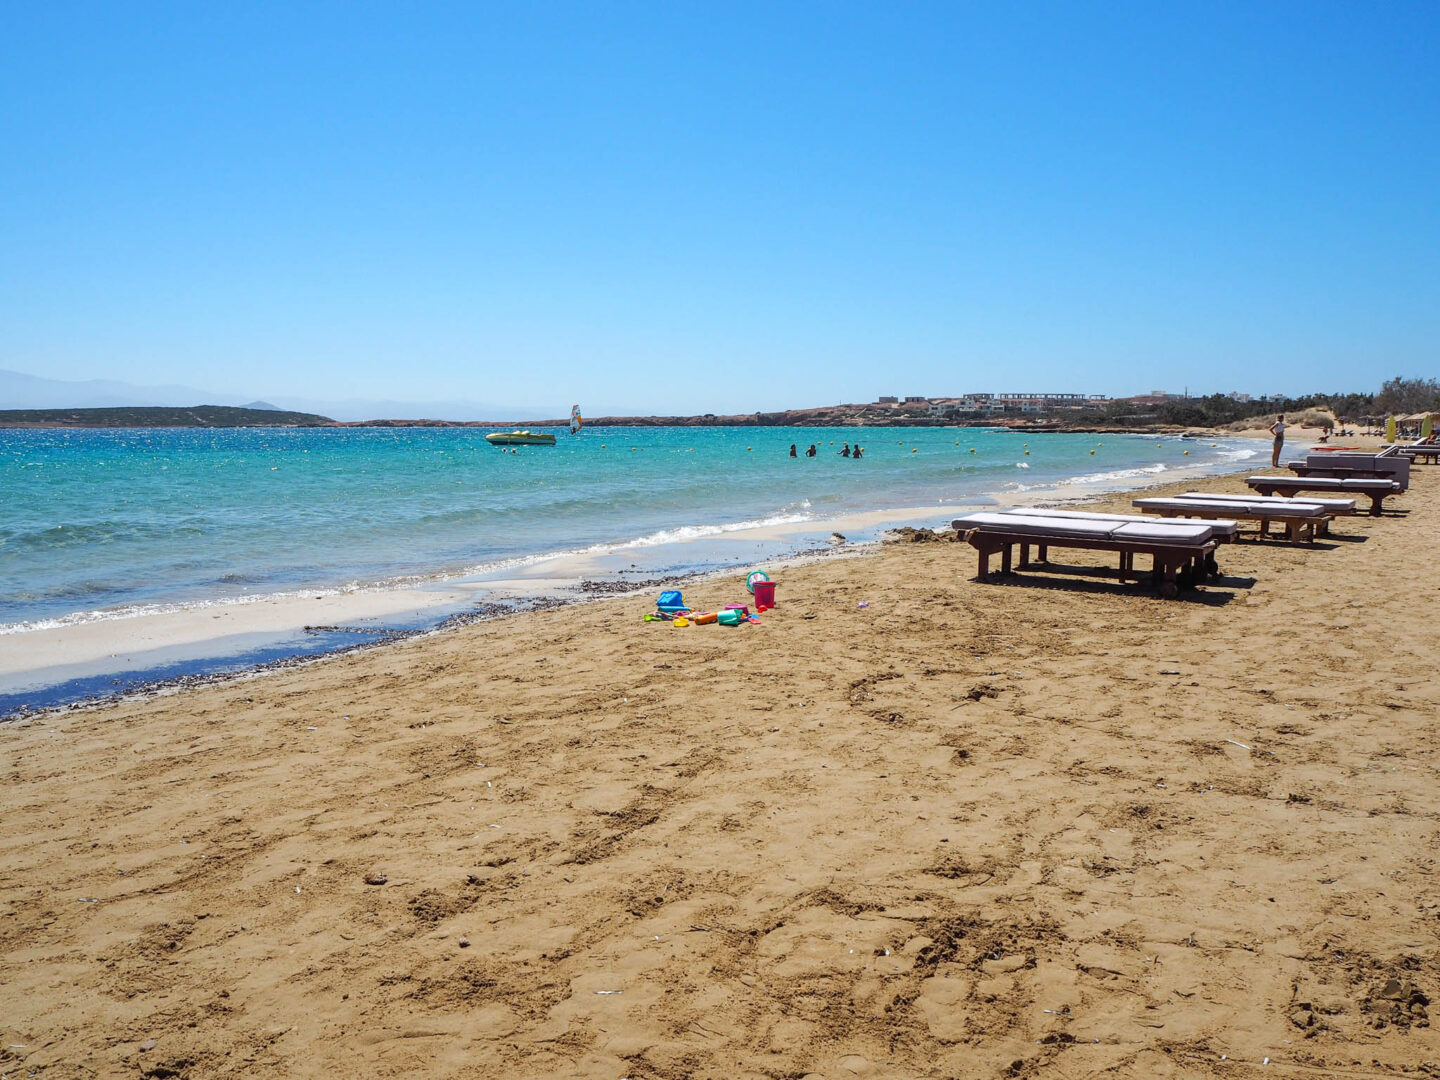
[952,510,1234,598]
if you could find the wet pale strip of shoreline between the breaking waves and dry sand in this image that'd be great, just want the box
[0,449,1261,723]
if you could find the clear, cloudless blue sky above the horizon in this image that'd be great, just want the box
[0,0,1440,413]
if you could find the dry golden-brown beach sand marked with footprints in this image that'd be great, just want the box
[0,457,1440,1080]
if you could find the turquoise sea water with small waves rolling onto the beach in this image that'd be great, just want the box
[0,428,1256,634]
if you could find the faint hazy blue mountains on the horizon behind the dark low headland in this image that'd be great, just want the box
[0,369,547,420]
